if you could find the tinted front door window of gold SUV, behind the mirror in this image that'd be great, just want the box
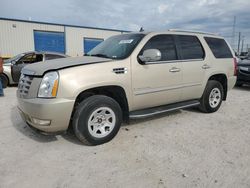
[140,35,177,61]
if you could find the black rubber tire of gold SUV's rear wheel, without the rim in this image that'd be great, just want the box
[203,80,224,113]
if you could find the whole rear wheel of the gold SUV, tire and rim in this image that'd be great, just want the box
[199,80,224,113]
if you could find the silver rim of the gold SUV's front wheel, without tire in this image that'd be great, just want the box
[88,107,116,138]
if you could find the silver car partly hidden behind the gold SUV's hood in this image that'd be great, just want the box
[1,51,69,88]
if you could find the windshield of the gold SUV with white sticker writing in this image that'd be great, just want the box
[86,34,145,59]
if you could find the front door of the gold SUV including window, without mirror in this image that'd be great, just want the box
[131,35,182,110]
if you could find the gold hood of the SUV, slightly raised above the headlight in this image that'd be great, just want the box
[22,56,112,76]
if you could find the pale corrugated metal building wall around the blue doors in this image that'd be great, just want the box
[0,19,124,56]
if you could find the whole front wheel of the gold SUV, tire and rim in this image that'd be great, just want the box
[72,95,122,145]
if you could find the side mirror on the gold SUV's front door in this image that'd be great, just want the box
[139,49,161,63]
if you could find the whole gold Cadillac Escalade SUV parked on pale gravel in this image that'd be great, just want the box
[17,30,236,145]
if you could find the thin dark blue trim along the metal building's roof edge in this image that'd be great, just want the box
[0,17,131,32]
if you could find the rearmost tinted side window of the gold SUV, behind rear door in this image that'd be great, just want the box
[205,37,233,58]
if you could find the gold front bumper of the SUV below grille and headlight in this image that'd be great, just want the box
[17,97,75,133]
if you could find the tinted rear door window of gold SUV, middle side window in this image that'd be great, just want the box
[178,35,205,59]
